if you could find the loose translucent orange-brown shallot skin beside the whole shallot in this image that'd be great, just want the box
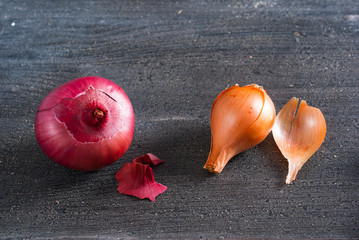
[272,97,326,184]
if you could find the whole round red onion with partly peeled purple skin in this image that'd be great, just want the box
[35,77,135,171]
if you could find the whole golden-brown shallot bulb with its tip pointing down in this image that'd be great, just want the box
[204,84,275,173]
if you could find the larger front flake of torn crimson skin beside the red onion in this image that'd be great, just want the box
[116,162,167,201]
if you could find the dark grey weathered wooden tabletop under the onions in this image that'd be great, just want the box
[0,0,359,239]
